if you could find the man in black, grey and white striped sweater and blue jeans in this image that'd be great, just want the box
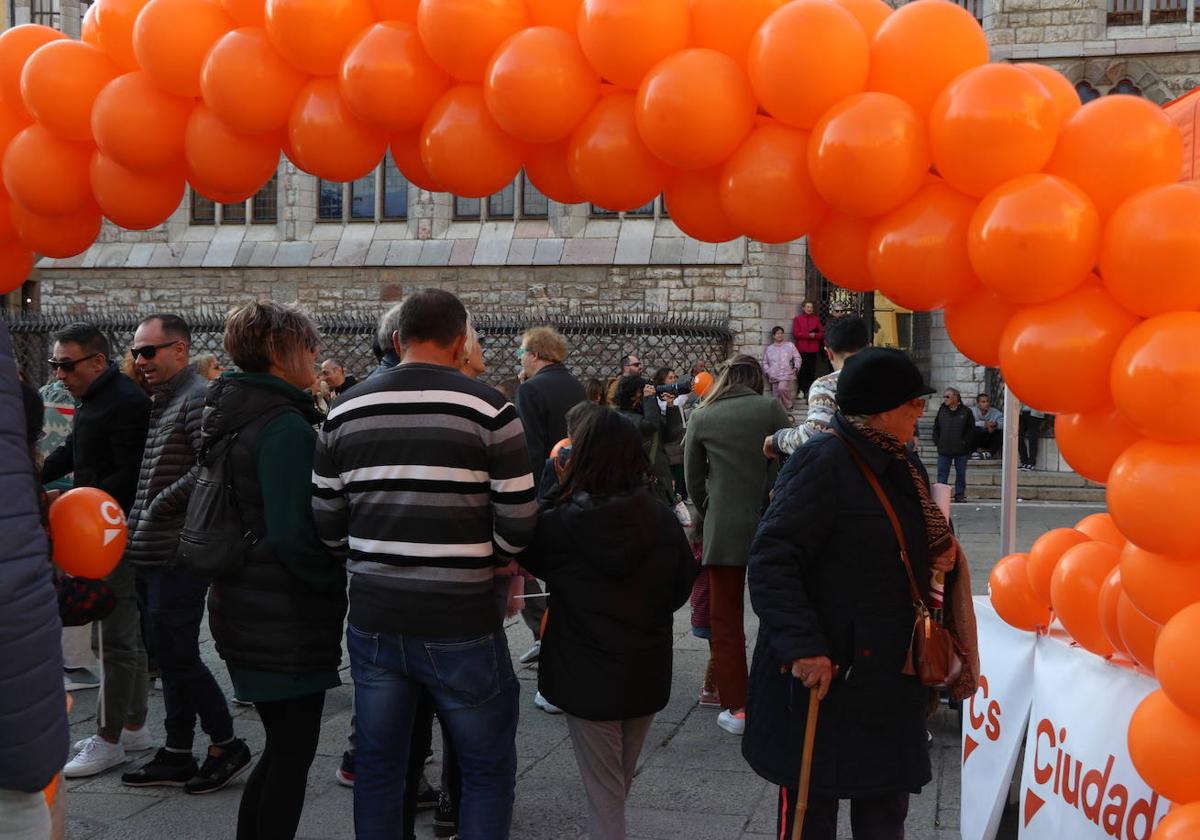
[313,289,536,840]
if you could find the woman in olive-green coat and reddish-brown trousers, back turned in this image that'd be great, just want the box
[683,354,788,734]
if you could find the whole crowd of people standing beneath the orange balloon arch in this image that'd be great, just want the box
[0,289,984,840]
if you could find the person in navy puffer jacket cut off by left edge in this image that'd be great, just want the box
[0,322,67,838]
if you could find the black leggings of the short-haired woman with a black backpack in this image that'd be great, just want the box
[238,691,325,840]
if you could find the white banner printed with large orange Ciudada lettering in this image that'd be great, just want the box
[1017,631,1170,840]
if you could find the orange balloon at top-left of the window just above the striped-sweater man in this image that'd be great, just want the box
[421,84,522,198]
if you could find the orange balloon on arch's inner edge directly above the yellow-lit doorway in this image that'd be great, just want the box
[866,182,979,312]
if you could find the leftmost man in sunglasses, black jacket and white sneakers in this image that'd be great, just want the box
[42,324,150,779]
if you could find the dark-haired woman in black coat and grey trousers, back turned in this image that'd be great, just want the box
[521,410,694,840]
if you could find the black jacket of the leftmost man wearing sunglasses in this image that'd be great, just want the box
[42,365,150,515]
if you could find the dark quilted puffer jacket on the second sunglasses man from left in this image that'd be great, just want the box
[126,365,209,566]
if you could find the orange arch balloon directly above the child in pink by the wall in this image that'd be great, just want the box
[721,120,828,242]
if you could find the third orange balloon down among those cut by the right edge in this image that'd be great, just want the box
[1108,438,1200,556]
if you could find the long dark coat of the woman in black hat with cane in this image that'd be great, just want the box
[742,414,932,799]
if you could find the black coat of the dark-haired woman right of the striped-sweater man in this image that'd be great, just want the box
[521,488,695,720]
